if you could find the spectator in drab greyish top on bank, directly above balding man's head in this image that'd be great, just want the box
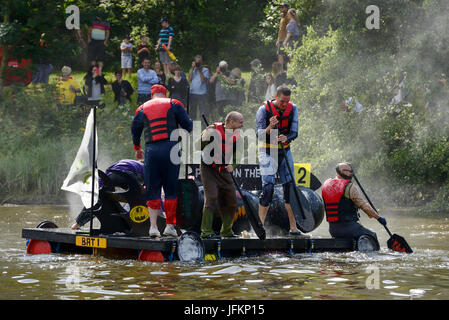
[210,60,235,118]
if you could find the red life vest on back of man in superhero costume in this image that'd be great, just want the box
[136,98,178,143]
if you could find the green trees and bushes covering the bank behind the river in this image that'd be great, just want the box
[0,0,449,210]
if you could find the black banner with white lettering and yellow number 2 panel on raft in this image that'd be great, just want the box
[188,163,312,190]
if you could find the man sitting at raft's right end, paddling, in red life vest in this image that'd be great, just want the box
[321,162,387,240]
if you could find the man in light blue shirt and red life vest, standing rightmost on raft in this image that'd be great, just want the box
[256,86,305,236]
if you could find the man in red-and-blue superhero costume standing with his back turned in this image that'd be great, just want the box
[131,85,193,237]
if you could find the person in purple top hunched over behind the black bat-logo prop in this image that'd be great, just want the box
[71,159,144,230]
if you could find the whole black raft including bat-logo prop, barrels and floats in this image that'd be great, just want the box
[22,172,378,262]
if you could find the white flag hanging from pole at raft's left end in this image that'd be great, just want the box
[61,109,98,208]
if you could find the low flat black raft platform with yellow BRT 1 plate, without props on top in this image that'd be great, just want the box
[22,227,364,262]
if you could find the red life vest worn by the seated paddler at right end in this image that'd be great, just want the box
[321,179,359,222]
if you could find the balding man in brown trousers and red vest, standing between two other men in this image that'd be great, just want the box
[200,111,243,239]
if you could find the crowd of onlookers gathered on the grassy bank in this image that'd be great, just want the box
[50,5,298,119]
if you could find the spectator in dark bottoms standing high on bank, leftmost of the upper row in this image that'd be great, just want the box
[87,16,111,71]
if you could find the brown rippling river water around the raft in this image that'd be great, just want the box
[0,206,449,300]
